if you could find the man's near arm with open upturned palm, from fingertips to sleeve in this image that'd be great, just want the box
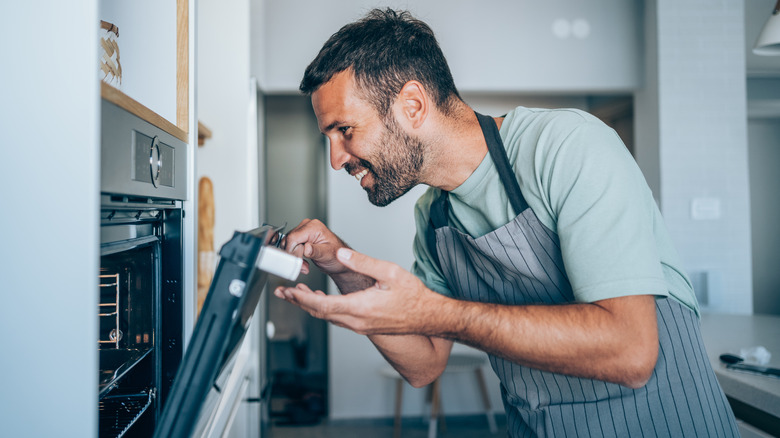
[277,249,658,388]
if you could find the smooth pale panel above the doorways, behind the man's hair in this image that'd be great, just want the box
[252,0,644,94]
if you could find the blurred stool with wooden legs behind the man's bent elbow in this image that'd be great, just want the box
[380,353,498,438]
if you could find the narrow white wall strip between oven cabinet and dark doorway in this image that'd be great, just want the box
[196,0,259,246]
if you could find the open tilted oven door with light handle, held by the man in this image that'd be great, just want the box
[154,225,301,438]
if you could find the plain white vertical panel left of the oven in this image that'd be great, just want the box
[0,0,100,437]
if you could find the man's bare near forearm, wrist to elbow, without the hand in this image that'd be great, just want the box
[423,296,658,387]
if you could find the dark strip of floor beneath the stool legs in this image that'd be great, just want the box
[269,415,506,438]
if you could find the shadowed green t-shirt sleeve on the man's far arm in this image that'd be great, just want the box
[412,189,452,297]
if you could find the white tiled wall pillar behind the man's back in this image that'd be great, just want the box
[636,0,753,313]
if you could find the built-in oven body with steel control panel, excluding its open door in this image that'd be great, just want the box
[96,100,188,437]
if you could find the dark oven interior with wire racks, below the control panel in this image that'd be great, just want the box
[97,204,181,437]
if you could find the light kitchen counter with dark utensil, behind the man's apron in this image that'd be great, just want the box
[701,314,780,433]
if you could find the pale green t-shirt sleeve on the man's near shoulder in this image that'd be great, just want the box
[536,119,668,302]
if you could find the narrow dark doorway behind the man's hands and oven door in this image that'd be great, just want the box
[265,96,328,426]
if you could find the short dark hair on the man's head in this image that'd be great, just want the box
[300,8,460,117]
